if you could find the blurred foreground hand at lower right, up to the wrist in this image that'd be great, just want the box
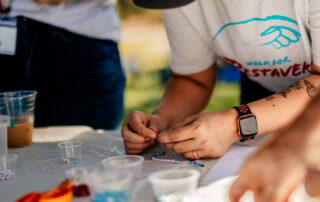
[229,138,307,202]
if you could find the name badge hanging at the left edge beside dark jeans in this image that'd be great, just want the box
[0,17,18,55]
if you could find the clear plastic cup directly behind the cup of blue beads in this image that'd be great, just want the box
[101,155,144,177]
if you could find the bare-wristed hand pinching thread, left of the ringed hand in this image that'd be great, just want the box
[121,111,166,154]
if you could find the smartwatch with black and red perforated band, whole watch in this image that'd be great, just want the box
[233,105,258,142]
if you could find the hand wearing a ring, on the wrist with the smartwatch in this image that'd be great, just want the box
[157,109,240,159]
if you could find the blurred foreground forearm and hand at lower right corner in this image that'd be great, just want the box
[230,90,320,202]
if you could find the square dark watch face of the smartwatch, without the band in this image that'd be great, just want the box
[239,115,258,138]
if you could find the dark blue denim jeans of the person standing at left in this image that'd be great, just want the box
[0,17,125,129]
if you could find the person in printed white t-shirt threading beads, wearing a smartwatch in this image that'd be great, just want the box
[122,0,320,159]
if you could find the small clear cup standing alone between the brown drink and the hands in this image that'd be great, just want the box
[58,141,83,165]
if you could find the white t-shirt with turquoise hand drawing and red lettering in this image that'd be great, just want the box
[162,0,320,92]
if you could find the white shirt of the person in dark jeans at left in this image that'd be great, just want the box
[10,0,120,42]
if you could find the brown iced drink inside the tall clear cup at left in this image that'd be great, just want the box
[8,117,34,147]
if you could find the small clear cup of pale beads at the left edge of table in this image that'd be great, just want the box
[0,154,18,181]
